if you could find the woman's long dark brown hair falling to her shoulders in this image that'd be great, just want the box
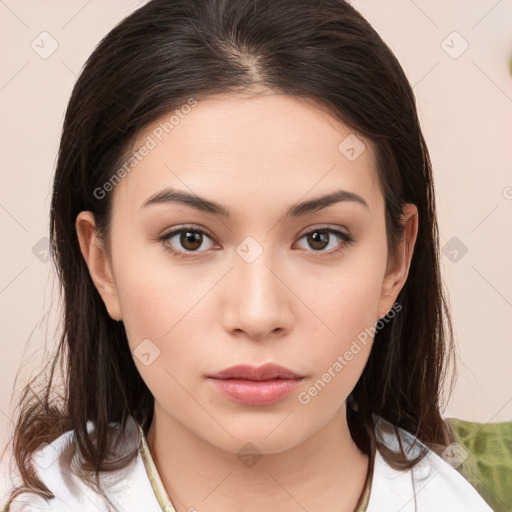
[1,0,453,508]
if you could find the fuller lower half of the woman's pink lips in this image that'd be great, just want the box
[208,377,302,405]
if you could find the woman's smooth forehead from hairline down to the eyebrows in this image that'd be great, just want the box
[114,92,379,211]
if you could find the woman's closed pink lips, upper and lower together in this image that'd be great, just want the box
[208,363,303,405]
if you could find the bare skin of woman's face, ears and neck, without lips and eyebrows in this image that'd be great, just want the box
[76,93,418,512]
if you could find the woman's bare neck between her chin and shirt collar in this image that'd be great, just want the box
[147,404,368,512]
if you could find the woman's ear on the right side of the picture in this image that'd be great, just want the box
[379,203,418,318]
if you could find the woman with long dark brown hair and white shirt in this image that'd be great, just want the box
[0,0,498,512]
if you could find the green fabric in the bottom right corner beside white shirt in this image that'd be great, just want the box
[446,418,512,512]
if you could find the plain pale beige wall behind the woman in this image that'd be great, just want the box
[0,0,512,476]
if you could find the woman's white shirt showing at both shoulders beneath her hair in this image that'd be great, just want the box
[2,418,492,512]
